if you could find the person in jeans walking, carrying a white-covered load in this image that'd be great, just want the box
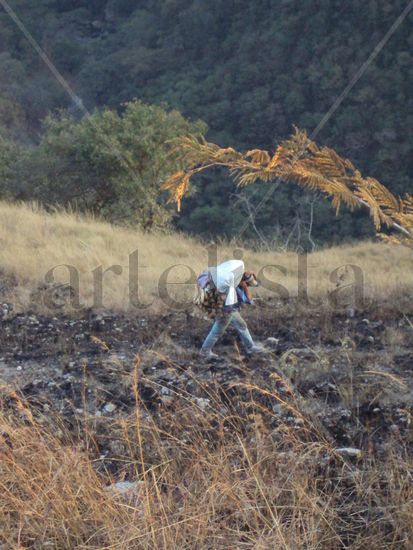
[197,260,266,359]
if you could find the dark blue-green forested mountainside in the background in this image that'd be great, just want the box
[0,0,413,246]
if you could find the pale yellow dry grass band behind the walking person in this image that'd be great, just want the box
[0,203,413,310]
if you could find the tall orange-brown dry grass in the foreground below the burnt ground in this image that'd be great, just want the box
[0,380,413,550]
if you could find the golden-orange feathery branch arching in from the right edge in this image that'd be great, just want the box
[163,129,413,246]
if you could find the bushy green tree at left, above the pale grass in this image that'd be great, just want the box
[6,101,206,227]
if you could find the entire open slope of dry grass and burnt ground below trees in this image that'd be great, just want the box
[0,203,413,550]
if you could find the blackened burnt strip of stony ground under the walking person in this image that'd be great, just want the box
[0,305,413,476]
